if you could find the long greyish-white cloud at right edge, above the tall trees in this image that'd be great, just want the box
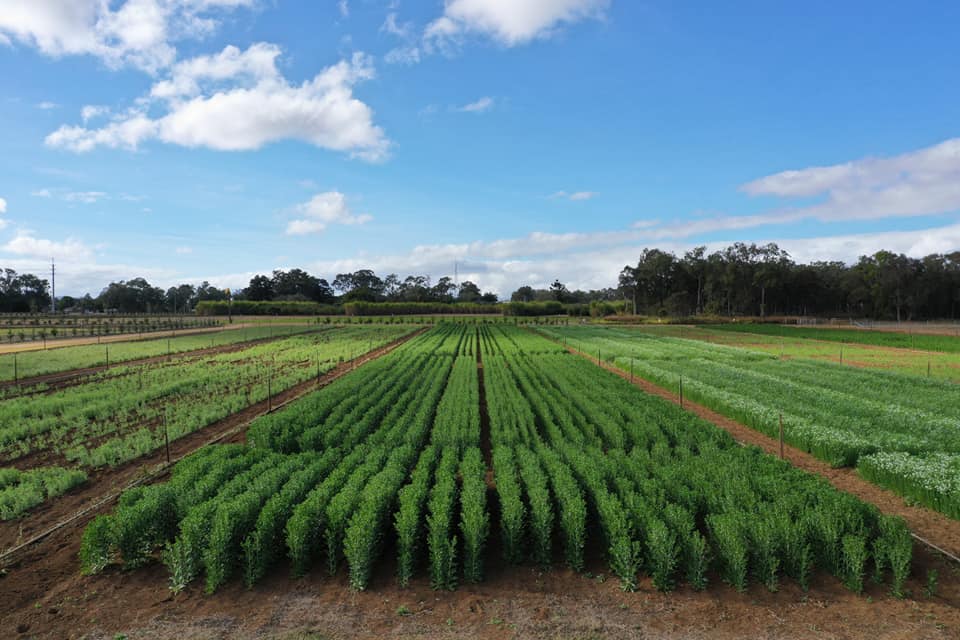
[741,138,960,221]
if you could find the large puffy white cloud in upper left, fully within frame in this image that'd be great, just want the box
[46,43,390,161]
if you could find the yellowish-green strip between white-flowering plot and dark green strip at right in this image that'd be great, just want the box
[611,325,960,382]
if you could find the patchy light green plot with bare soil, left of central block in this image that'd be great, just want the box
[0,326,411,518]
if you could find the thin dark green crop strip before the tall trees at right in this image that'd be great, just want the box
[709,324,960,353]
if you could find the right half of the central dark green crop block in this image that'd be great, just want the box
[484,324,912,594]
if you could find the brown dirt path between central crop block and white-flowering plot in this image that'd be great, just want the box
[567,346,960,556]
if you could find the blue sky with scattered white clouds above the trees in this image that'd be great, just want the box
[0,0,960,295]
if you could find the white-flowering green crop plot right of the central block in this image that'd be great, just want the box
[544,327,960,517]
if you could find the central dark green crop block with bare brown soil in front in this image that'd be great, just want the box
[0,323,960,638]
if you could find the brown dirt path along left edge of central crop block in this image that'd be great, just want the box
[0,329,425,566]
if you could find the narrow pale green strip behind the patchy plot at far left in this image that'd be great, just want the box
[0,325,316,381]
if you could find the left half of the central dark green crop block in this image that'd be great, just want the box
[81,326,489,591]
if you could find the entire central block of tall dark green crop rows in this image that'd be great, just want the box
[81,325,912,594]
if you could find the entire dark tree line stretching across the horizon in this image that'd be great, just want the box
[7,242,960,321]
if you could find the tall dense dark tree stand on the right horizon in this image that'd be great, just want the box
[618,242,960,322]
